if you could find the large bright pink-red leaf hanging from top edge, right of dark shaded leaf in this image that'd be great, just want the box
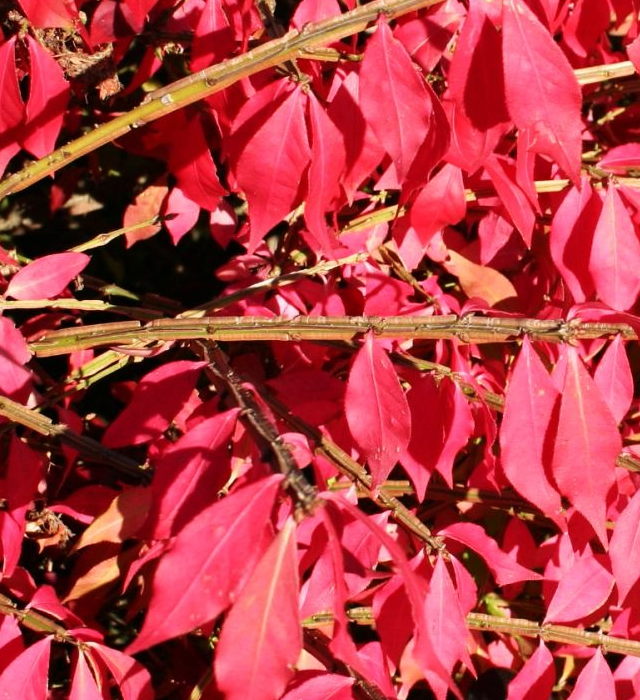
[502,0,582,185]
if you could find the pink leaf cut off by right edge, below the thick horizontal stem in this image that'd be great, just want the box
[609,491,640,604]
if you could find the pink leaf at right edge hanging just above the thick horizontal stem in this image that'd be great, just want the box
[589,183,640,311]
